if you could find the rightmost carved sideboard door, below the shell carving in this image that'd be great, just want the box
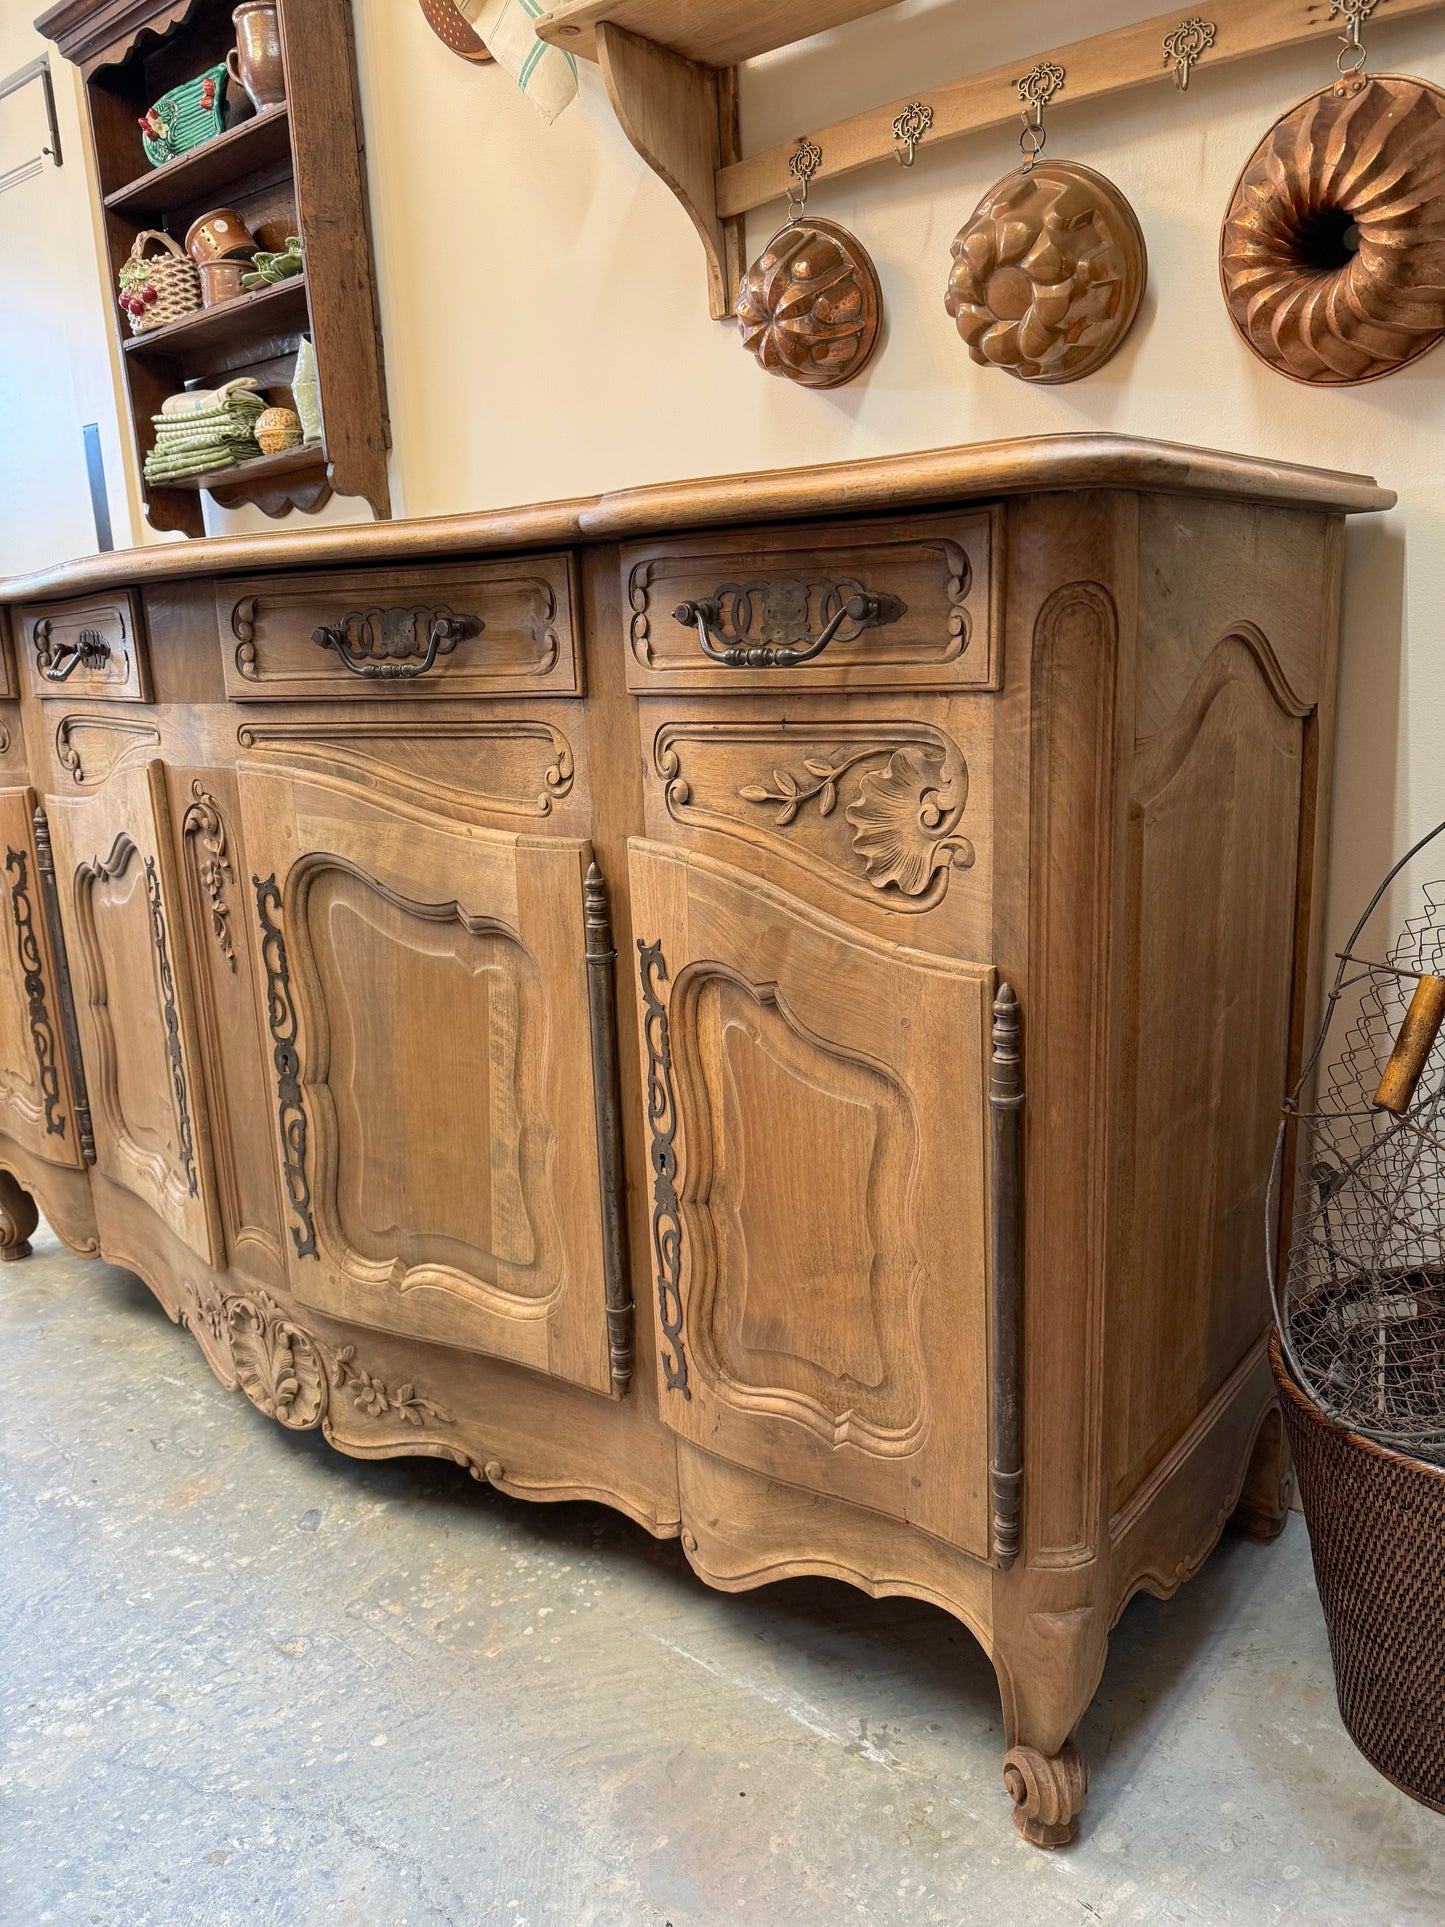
[630,842,994,1557]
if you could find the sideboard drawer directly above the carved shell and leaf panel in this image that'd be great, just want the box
[622,509,1000,696]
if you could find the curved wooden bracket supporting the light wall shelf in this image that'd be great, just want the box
[597,21,744,322]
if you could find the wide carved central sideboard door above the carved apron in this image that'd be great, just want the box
[239,765,613,1391]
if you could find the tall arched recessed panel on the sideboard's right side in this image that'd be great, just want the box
[1112,624,1308,1511]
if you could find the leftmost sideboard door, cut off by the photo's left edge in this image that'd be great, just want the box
[0,790,89,1166]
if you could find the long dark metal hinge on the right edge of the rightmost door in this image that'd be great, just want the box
[988,983,1023,1571]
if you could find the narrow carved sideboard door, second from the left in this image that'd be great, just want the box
[48,761,222,1264]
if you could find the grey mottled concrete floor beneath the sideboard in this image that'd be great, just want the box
[0,1229,1445,1927]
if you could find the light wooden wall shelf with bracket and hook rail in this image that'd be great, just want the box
[538,0,1445,320]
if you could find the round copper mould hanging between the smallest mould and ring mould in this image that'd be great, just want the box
[944,160,1148,382]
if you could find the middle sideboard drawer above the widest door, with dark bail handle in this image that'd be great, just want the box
[216,555,582,701]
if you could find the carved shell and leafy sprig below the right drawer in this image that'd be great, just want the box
[738,744,973,896]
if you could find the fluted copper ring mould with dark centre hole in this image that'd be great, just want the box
[1220,75,1445,385]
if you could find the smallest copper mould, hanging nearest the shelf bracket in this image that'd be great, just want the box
[734,218,882,387]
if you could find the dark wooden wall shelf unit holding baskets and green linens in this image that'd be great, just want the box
[37,0,391,536]
